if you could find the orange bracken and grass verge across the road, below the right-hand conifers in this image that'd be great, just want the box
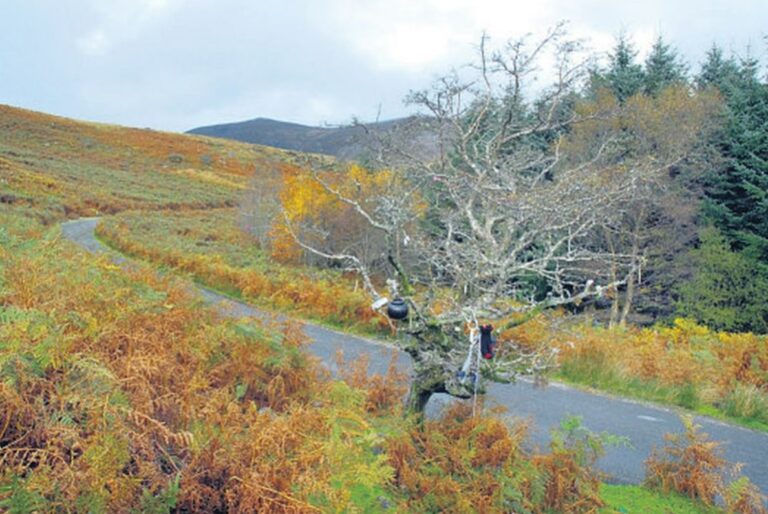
[520,318,768,424]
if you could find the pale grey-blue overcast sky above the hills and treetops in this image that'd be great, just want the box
[0,0,768,131]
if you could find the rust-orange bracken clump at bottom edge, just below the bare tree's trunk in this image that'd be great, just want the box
[387,403,602,514]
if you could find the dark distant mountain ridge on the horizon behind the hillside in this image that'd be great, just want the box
[187,118,414,158]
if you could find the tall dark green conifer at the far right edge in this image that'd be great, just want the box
[694,51,768,331]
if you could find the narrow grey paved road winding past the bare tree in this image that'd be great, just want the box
[62,218,768,492]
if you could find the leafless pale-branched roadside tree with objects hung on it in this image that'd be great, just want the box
[274,26,708,413]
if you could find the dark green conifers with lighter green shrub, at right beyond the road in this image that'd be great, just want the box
[588,34,768,333]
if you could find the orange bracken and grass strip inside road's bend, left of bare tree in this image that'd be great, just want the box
[96,209,385,334]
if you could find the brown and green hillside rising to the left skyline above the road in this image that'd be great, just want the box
[0,106,288,223]
